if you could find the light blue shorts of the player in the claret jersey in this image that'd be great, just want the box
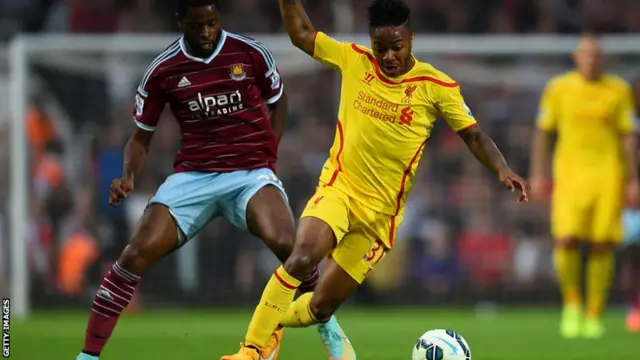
[149,169,287,242]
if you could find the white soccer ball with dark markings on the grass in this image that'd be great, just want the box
[412,329,471,360]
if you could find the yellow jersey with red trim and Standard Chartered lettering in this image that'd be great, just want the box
[313,32,476,216]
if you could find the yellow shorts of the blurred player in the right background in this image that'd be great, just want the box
[551,179,624,243]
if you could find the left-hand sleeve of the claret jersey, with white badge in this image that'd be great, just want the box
[133,68,166,131]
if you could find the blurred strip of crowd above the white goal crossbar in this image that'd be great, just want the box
[6,0,640,34]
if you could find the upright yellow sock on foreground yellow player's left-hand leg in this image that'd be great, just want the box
[245,266,300,349]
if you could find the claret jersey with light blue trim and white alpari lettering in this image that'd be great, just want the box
[133,31,284,172]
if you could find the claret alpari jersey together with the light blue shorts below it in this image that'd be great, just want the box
[133,31,285,240]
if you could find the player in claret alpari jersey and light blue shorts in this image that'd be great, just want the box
[77,0,350,360]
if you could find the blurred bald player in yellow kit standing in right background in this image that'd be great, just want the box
[531,36,638,338]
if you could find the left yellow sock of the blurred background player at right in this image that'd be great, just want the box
[553,247,582,306]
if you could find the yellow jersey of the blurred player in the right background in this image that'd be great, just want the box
[537,71,636,180]
